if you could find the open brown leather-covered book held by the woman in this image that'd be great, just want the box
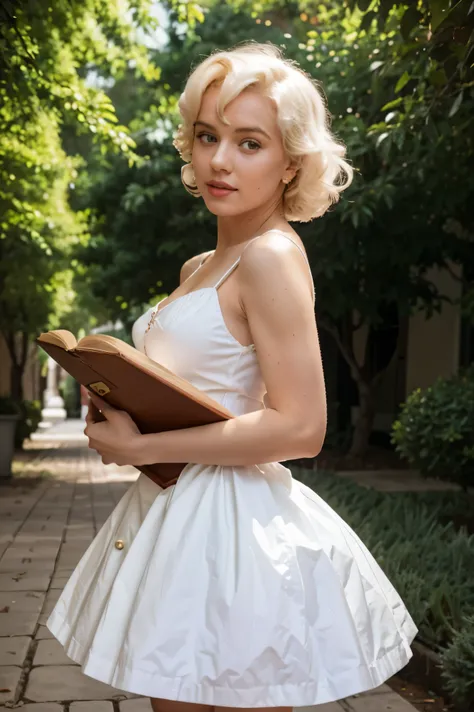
[36,329,234,487]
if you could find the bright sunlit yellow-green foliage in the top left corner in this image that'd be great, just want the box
[0,0,159,152]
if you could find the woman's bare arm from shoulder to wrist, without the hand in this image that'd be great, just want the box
[133,234,326,466]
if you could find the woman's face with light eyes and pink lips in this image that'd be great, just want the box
[192,86,294,216]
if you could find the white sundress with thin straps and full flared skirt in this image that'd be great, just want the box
[47,233,418,707]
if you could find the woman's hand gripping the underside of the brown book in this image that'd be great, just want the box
[84,393,141,465]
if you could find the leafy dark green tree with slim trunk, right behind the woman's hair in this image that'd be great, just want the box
[280,1,474,456]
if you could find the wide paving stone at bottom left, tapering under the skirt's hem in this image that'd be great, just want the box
[24,665,133,702]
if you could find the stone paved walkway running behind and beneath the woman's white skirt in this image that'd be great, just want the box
[0,421,415,712]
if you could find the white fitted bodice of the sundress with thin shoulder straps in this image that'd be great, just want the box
[132,233,309,415]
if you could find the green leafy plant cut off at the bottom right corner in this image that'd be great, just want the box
[441,614,474,712]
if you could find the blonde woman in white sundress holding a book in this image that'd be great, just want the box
[48,43,417,712]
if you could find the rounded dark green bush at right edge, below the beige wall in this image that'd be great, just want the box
[392,366,474,490]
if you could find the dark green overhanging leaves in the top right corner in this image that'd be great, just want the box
[294,0,474,133]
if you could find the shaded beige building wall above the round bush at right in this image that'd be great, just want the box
[406,265,462,395]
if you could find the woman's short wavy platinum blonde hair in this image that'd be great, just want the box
[173,42,353,222]
